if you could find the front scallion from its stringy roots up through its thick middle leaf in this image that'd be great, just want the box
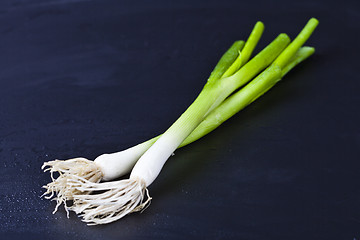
[69,34,289,225]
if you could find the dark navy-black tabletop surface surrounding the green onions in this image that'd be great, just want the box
[0,0,360,240]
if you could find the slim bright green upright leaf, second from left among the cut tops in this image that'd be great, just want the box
[222,21,264,78]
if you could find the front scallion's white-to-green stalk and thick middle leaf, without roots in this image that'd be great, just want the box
[130,34,290,186]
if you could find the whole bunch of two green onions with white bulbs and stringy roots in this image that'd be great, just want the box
[42,18,318,225]
